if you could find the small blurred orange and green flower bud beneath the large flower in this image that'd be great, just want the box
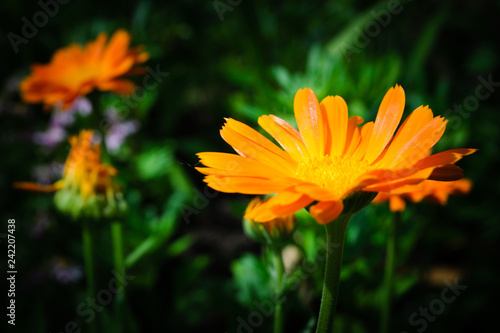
[243,197,295,246]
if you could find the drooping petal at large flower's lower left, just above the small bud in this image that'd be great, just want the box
[245,192,313,222]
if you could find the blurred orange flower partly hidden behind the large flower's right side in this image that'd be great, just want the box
[373,178,472,212]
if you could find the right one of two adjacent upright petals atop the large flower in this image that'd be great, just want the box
[320,96,348,156]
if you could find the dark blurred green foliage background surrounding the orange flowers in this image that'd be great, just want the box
[0,0,500,332]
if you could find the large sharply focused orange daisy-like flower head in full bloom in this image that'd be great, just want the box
[197,85,475,224]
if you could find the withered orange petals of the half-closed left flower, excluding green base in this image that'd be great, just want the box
[14,130,117,203]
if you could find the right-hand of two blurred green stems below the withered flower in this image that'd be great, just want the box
[111,221,125,332]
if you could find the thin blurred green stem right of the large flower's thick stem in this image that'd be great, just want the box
[380,212,401,333]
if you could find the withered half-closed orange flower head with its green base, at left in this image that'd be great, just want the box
[14,130,126,218]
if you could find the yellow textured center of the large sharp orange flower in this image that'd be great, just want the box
[296,155,373,195]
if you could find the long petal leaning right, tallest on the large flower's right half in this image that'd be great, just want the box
[365,85,405,163]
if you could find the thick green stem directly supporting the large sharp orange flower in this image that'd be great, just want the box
[316,214,352,333]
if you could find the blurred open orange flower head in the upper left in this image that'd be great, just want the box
[21,30,149,109]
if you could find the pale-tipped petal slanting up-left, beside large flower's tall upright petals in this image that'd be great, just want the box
[258,115,309,162]
